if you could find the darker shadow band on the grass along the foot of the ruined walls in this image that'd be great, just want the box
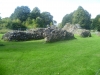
[0,39,75,52]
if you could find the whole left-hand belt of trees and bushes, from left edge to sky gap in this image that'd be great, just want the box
[0,6,56,29]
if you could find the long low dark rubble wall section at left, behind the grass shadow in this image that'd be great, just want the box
[2,29,44,41]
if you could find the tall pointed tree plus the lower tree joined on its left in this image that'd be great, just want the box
[62,6,91,29]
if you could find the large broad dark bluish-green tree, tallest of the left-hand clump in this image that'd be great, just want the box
[10,6,30,22]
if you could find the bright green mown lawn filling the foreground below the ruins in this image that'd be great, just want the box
[0,35,100,75]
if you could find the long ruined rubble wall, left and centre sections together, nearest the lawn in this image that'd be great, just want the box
[2,27,74,42]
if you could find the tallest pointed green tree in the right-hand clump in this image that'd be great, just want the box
[72,6,91,29]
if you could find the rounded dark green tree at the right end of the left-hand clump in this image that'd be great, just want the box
[41,12,53,27]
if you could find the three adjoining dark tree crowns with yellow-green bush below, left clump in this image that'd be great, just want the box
[10,6,53,28]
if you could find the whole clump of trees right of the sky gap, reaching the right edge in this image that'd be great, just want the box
[58,6,100,31]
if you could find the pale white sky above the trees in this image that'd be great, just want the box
[0,0,100,23]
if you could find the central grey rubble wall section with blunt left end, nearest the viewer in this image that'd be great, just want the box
[44,28,74,42]
